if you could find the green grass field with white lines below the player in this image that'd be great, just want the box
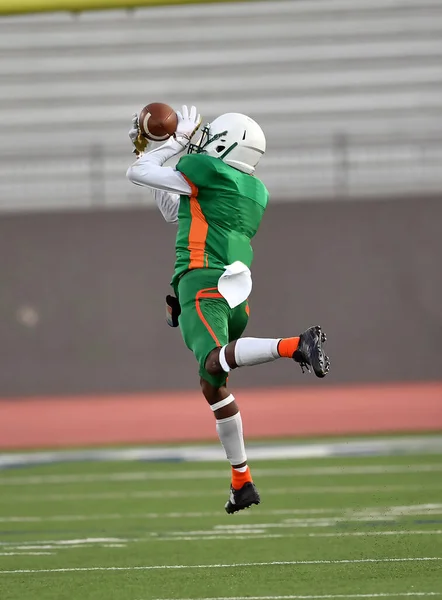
[0,446,442,600]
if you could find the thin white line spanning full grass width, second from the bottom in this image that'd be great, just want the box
[0,556,442,575]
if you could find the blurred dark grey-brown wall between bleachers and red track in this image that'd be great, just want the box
[0,197,442,397]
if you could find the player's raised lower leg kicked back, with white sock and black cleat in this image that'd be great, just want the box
[206,326,330,377]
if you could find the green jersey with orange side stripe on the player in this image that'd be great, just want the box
[172,154,269,287]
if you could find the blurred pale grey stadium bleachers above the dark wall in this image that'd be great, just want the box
[0,0,442,211]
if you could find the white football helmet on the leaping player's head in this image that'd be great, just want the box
[188,113,266,175]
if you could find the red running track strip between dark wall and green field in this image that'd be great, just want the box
[0,382,442,449]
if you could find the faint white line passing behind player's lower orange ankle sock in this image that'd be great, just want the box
[0,464,442,485]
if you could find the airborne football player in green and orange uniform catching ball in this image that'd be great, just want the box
[127,106,330,513]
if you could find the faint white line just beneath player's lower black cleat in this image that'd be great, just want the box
[0,504,442,523]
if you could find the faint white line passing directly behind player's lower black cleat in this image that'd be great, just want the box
[0,484,442,504]
